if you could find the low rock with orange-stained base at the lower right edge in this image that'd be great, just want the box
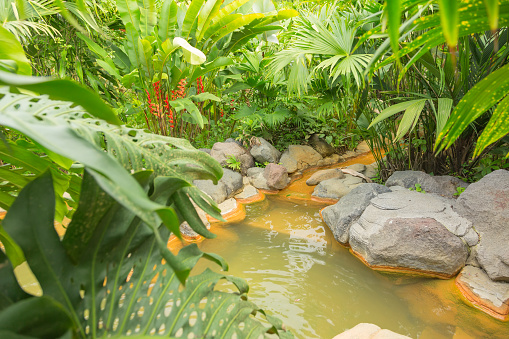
[456,266,509,315]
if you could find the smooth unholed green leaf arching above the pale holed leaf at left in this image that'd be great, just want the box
[0,71,121,124]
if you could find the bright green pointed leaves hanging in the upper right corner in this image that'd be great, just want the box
[361,0,509,156]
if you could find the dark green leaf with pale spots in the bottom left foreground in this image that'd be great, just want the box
[1,175,290,338]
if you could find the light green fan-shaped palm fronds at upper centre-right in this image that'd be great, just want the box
[269,4,371,96]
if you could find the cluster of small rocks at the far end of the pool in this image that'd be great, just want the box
[194,135,370,204]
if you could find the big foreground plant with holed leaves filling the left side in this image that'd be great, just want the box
[0,31,291,338]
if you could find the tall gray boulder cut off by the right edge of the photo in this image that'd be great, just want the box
[454,170,509,282]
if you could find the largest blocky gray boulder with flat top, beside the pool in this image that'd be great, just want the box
[349,190,472,276]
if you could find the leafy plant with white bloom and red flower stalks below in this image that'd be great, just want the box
[81,0,295,136]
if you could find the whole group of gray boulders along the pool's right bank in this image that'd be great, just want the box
[321,170,509,320]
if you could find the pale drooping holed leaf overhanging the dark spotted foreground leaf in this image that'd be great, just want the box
[0,89,222,281]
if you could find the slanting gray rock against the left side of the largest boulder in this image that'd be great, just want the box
[322,184,391,244]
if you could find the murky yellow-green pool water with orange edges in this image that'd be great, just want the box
[192,197,509,339]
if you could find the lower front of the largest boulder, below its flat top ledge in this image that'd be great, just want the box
[350,216,468,276]
